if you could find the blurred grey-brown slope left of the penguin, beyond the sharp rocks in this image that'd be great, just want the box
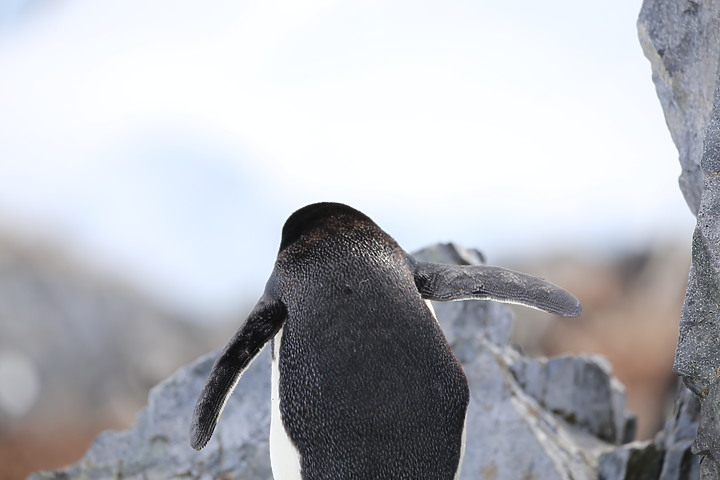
[0,232,237,478]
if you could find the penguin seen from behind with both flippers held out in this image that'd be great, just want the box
[190,203,581,480]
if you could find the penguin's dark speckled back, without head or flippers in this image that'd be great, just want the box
[276,238,469,480]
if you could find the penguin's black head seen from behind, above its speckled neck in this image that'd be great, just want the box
[280,202,375,251]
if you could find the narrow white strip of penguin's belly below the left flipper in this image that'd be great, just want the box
[270,329,302,480]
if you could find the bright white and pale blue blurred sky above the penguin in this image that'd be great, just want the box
[0,0,693,316]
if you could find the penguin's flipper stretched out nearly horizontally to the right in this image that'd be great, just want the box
[414,261,582,317]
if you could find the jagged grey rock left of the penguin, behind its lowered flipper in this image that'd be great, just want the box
[29,351,272,480]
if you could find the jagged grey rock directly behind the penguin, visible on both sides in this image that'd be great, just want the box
[31,245,633,480]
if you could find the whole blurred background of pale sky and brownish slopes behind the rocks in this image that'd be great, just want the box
[0,0,694,479]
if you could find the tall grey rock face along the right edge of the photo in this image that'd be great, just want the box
[638,0,720,478]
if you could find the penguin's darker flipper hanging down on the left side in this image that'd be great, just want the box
[190,294,287,450]
